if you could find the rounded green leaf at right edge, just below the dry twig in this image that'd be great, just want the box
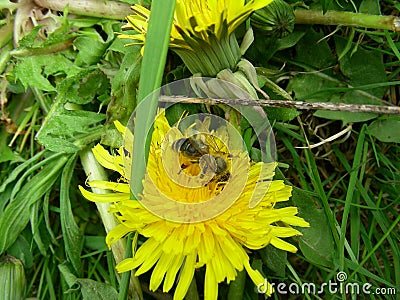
[368,117,400,143]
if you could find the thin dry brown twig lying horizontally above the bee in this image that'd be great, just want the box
[159,95,400,115]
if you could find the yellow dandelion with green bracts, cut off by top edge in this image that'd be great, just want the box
[119,0,273,76]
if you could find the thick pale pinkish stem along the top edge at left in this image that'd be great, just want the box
[34,0,131,20]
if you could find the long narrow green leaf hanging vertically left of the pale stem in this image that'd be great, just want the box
[60,155,84,274]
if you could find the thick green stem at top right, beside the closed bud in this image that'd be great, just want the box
[294,9,400,32]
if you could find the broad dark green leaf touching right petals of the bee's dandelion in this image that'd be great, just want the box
[292,188,333,267]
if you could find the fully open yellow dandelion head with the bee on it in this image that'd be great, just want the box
[79,113,309,299]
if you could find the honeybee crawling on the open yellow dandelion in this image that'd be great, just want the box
[172,135,230,182]
